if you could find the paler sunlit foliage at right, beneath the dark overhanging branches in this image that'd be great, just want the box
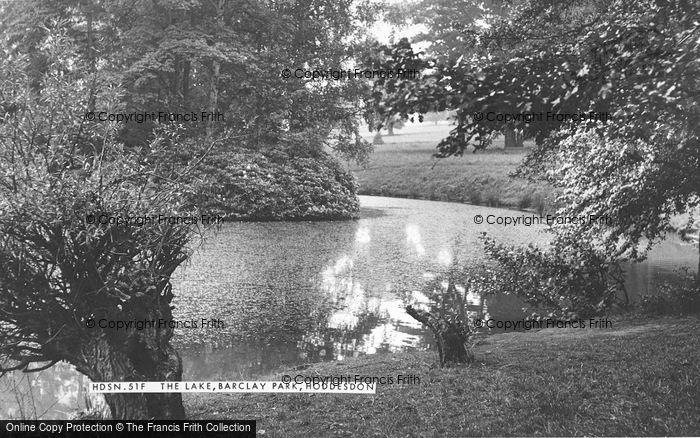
[532,125,700,259]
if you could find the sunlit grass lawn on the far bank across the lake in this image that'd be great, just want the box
[349,124,552,212]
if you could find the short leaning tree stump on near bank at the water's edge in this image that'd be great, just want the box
[406,306,474,367]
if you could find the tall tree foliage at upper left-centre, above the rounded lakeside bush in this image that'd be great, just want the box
[87,0,371,161]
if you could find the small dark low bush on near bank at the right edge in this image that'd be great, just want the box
[639,269,700,315]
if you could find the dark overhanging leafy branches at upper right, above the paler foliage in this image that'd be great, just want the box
[386,0,698,156]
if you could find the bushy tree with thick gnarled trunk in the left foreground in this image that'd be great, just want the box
[0,28,202,419]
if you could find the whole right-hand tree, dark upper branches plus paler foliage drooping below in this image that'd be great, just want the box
[378,0,700,296]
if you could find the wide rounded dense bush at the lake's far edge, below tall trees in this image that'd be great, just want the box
[180,143,359,220]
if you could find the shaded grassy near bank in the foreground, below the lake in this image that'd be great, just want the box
[185,316,700,437]
